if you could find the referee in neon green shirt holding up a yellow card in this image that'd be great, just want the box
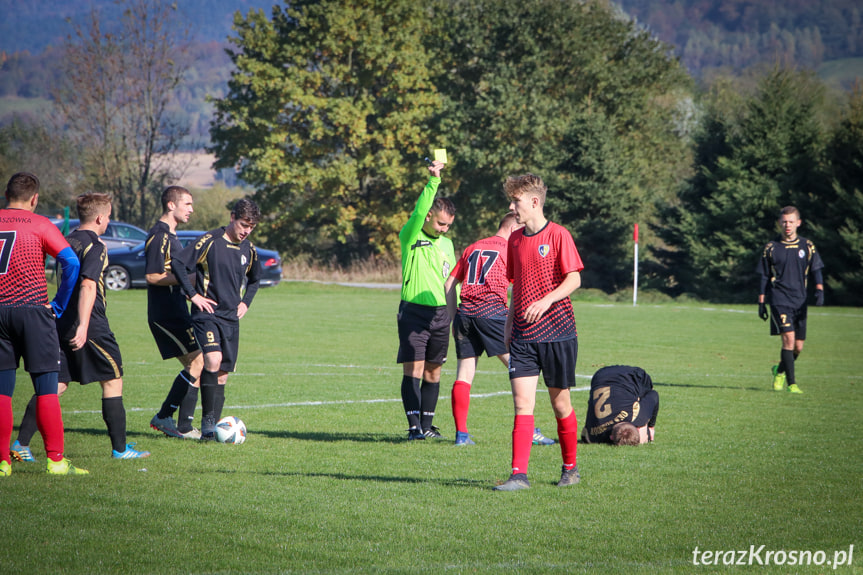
[397,161,456,440]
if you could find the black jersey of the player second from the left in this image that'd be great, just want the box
[57,229,108,335]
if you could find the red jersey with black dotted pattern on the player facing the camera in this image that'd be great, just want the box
[506,222,584,342]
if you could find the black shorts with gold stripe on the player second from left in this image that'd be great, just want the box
[58,320,123,385]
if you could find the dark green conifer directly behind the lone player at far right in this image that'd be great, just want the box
[660,69,825,301]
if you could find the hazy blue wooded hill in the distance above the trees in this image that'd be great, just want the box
[0,0,863,133]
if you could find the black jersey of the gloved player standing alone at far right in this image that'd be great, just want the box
[759,236,824,309]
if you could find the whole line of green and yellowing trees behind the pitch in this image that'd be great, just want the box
[0,0,863,305]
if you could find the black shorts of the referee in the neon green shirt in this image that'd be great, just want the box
[396,301,449,364]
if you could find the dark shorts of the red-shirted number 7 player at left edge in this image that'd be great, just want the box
[0,306,60,373]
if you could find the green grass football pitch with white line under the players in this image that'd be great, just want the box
[0,283,863,574]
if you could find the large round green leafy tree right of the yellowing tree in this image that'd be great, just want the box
[438,0,689,291]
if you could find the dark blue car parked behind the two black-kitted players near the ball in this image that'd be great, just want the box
[105,230,282,290]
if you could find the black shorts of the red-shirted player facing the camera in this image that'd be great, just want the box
[509,337,578,389]
